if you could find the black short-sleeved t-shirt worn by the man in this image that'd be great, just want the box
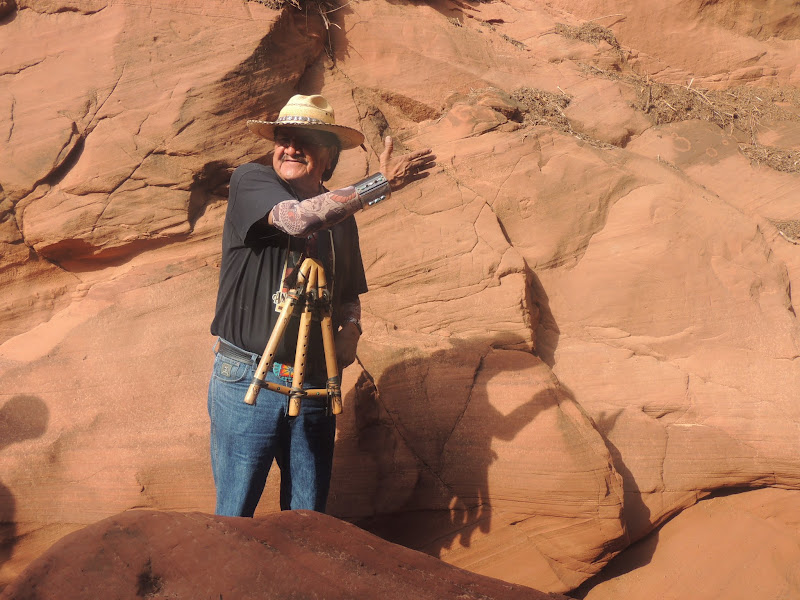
[211,163,367,380]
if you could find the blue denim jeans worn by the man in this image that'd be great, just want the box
[208,346,336,517]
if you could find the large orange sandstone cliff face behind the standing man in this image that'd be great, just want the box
[0,0,800,598]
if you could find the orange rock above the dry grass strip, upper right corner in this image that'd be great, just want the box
[552,0,800,87]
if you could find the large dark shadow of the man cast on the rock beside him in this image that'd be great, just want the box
[334,339,560,556]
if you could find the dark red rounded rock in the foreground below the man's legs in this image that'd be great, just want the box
[0,511,564,600]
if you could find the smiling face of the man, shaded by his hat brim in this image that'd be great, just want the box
[272,127,332,196]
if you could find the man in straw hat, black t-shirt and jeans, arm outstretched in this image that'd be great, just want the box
[208,95,435,516]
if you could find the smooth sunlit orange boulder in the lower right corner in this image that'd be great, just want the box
[580,488,800,600]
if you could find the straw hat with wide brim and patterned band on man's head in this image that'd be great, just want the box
[247,94,364,150]
